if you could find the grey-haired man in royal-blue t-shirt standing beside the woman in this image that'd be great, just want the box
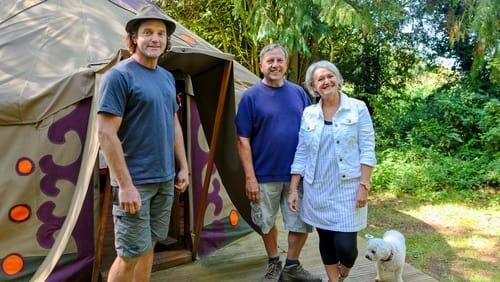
[235,44,321,281]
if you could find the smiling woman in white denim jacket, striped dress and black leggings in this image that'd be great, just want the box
[288,61,376,281]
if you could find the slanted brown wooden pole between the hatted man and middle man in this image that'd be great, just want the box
[193,61,233,259]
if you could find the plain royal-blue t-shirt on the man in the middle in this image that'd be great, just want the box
[236,80,311,183]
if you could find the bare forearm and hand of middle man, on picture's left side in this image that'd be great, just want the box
[238,136,260,203]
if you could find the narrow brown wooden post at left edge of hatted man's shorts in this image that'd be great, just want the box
[92,173,111,282]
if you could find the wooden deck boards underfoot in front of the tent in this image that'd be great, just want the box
[151,219,437,282]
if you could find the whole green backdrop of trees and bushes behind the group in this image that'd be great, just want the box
[156,0,500,196]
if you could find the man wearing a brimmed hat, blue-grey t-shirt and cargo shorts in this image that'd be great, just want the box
[97,5,189,281]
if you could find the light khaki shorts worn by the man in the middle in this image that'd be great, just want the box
[250,182,313,234]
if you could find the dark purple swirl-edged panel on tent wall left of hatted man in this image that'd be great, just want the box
[36,98,94,281]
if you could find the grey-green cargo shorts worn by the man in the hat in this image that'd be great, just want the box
[113,180,174,257]
